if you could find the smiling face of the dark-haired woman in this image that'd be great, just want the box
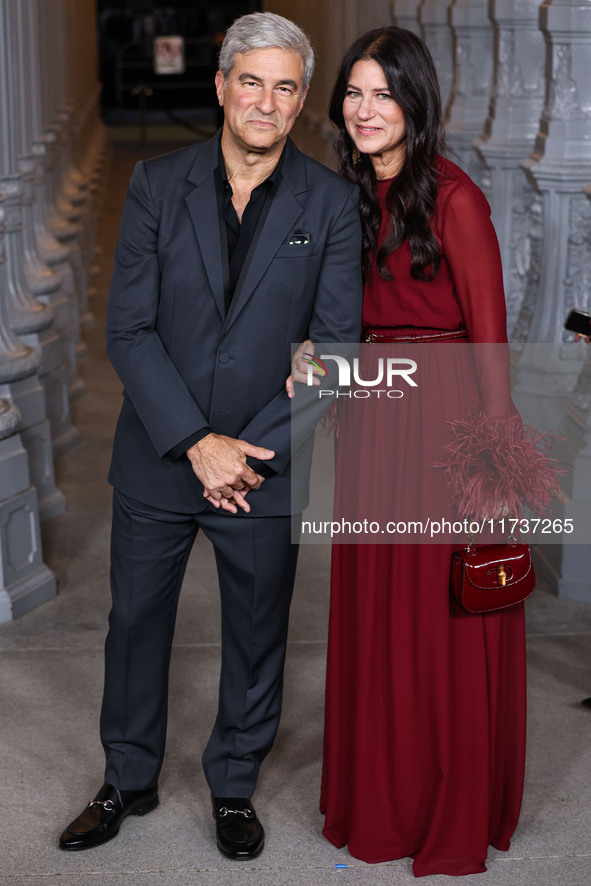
[343,59,406,173]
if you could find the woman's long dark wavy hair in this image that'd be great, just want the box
[329,27,445,280]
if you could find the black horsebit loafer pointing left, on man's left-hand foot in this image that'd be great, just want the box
[59,784,159,851]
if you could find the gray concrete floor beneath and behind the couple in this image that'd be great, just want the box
[0,140,591,886]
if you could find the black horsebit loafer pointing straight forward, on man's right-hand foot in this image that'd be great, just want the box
[211,795,265,861]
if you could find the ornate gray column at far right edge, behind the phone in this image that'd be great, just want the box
[514,0,591,598]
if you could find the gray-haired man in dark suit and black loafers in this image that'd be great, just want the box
[60,13,361,858]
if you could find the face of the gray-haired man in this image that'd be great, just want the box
[215,48,308,154]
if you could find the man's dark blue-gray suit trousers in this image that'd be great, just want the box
[101,490,298,797]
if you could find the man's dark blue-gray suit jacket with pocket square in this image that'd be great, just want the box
[107,133,362,516]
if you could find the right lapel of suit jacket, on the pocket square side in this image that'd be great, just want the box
[223,139,307,332]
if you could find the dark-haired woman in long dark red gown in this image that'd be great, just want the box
[292,27,526,877]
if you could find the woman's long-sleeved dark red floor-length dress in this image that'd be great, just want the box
[320,158,526,877]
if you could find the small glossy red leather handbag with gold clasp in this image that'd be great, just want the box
[450,542,536,612]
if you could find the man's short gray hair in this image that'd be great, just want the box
[219,12,314,90]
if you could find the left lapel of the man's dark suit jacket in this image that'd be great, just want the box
[185,136,226,318]
